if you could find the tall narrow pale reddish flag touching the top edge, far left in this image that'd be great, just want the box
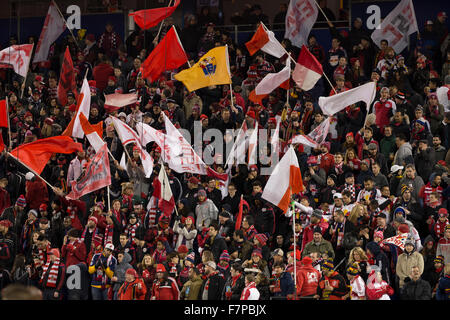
[33,1,67,63]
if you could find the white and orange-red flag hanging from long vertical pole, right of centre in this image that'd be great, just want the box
[262,146,303,212]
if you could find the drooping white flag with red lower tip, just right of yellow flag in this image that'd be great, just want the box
[249,59,291,104]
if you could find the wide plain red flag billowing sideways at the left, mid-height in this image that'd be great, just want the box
[11,136,83,174]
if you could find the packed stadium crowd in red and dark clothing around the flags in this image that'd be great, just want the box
[0,5,450,300]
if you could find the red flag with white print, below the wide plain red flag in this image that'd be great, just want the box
[66,143,111,200]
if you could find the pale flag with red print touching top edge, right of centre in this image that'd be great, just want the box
[284,0,319,48]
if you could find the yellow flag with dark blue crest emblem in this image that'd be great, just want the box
[174,46,231,92]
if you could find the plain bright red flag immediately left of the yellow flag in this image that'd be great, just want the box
[141,27,188,82]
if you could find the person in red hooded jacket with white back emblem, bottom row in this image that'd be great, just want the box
[297,256,321,297]
